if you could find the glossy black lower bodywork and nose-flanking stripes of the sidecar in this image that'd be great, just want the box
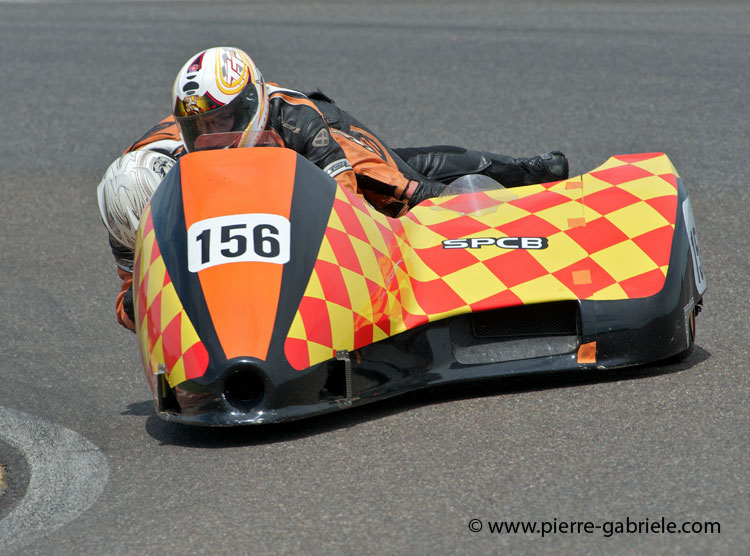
[152,161,701,426]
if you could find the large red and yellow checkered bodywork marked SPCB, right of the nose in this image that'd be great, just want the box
[284,153,678,370]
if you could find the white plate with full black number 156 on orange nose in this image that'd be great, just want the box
[188,214,291,272]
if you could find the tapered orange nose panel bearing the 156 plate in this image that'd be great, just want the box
[180,148,296,360]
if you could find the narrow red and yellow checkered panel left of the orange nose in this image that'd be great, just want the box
[133,206,208,386]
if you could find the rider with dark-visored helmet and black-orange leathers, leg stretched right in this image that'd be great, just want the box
[99,47,568,329]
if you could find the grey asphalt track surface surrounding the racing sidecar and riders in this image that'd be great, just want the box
[0,0,750,555]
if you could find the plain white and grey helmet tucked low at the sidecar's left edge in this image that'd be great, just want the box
[96,150,175,249]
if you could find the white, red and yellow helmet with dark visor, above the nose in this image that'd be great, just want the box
[172,46,268,151]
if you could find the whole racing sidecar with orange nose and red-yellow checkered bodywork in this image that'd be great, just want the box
[133,144,706,426]
